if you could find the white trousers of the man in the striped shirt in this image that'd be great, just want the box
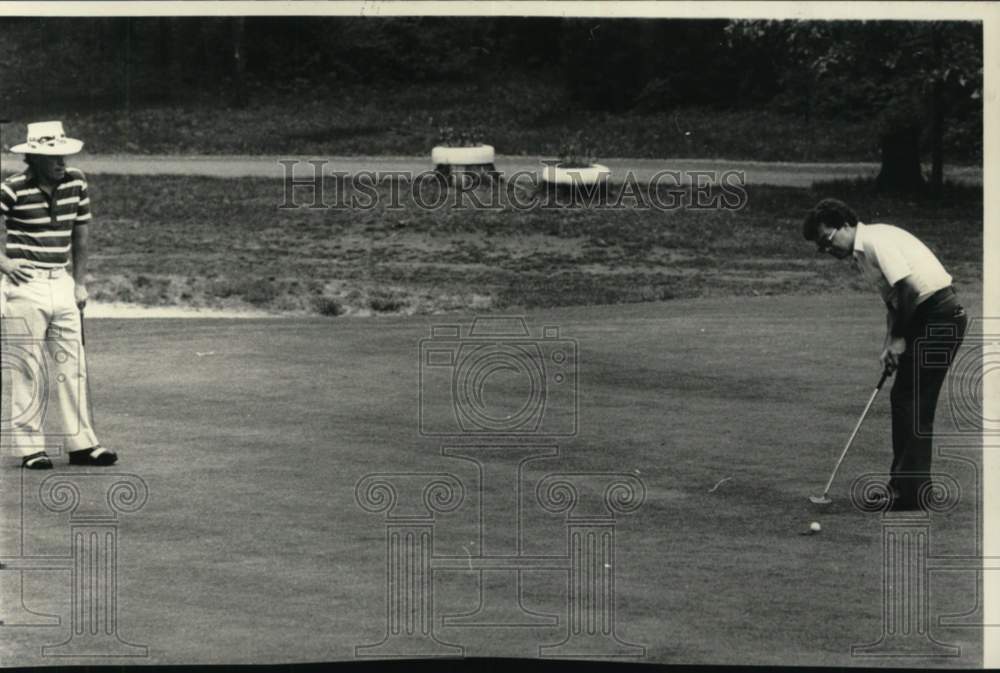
[0,269,98,457]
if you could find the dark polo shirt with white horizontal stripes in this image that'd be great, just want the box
[0,167,91,269]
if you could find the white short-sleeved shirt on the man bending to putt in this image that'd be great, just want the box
[854,222,951,309]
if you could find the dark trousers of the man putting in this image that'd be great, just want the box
[889,288,968,505]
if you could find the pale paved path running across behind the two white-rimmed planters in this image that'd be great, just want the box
[0,154,982,187]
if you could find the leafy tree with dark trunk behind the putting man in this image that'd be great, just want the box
[726,21,983,191]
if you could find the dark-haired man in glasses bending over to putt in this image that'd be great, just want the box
[803,199,968,510]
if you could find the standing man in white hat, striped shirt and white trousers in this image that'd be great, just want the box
[0,121,118,470]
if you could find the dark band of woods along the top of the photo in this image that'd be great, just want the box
[0,17,982,191]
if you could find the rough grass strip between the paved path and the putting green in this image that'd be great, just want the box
[74,175,982,315]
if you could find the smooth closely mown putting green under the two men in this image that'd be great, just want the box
[0,293,982,667]
